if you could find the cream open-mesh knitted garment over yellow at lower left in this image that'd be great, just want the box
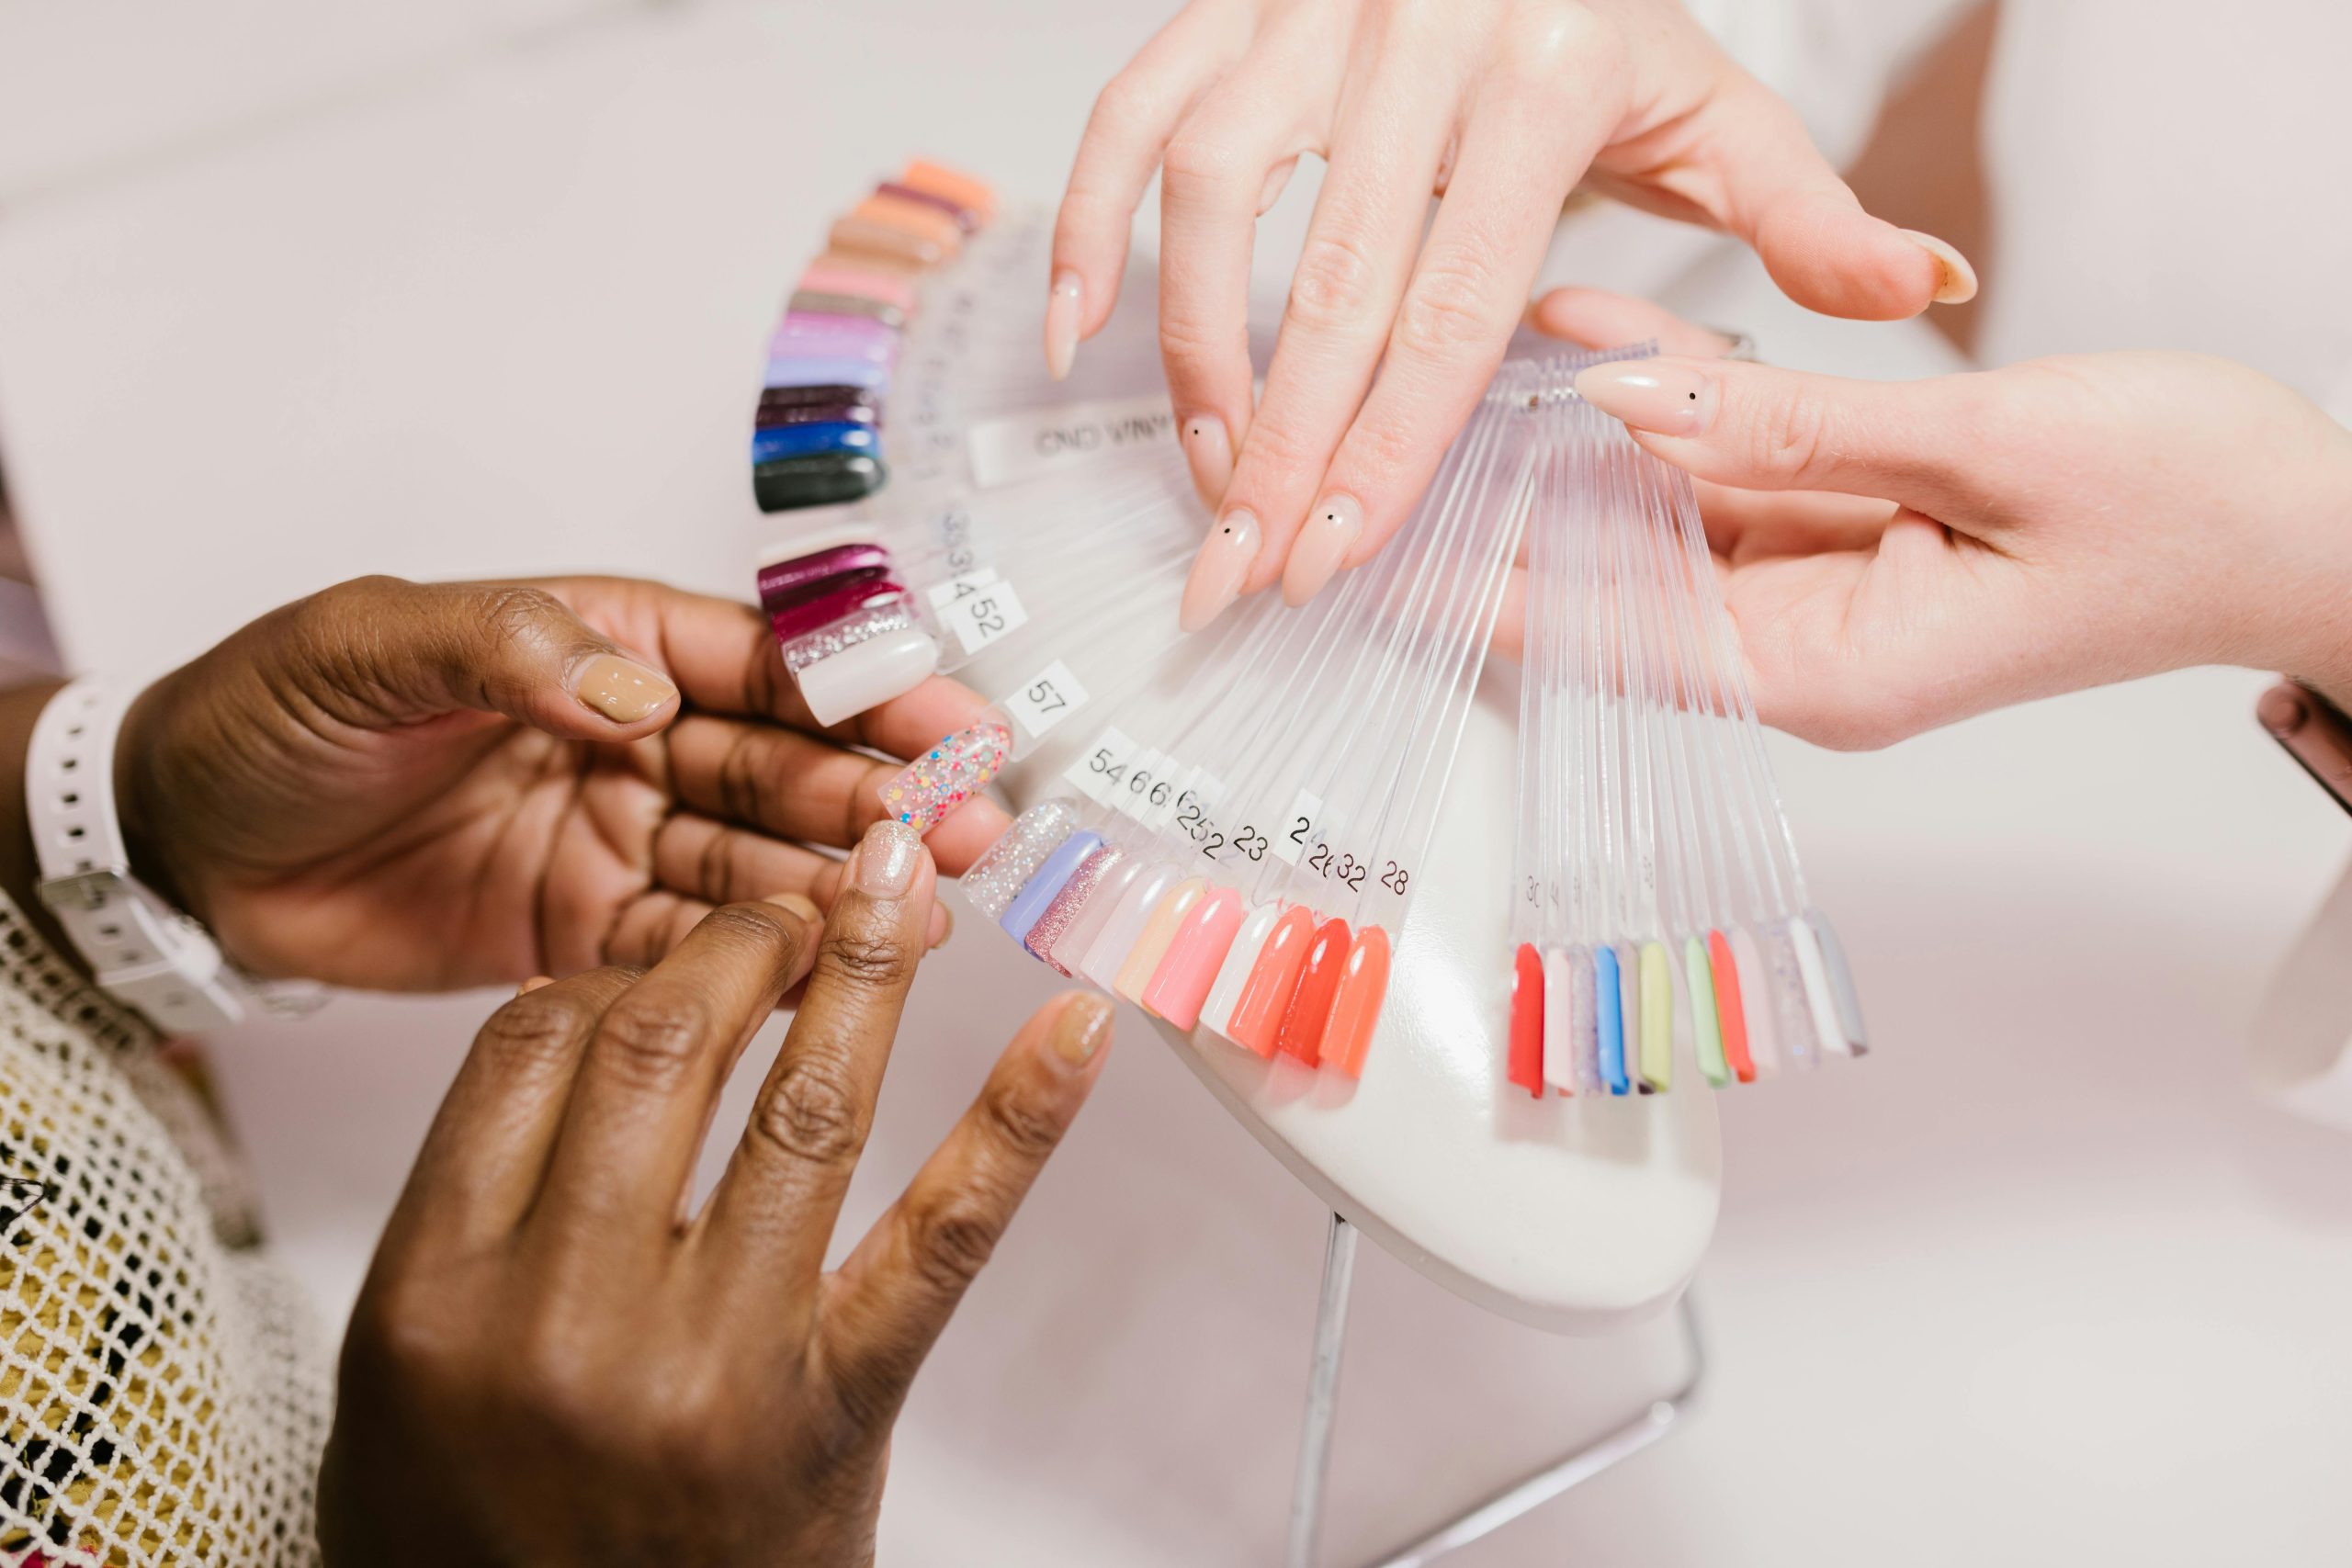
[0,896,334,1568]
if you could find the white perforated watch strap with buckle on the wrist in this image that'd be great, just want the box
[24,677,247,1034]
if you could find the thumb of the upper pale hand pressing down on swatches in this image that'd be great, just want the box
[1701,83,1975,322]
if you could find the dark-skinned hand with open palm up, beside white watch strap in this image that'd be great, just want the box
[115,579,1004,989]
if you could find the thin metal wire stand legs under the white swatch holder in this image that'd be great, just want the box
[1284,1213,1708,1568]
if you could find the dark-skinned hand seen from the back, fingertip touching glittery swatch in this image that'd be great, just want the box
[320,823,1110,1568]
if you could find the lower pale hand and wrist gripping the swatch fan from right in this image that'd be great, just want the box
[1503,289,2352,748]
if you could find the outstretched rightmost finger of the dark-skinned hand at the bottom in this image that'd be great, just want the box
[823,995,1110,1422]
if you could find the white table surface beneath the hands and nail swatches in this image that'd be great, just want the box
[0,0,2352,1568]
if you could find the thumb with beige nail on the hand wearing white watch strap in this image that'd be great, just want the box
[280,576,677,740]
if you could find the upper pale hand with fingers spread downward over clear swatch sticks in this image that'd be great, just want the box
[1046,0,1975,627]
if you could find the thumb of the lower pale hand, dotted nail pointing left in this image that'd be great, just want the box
[1576,355,1981,514]
